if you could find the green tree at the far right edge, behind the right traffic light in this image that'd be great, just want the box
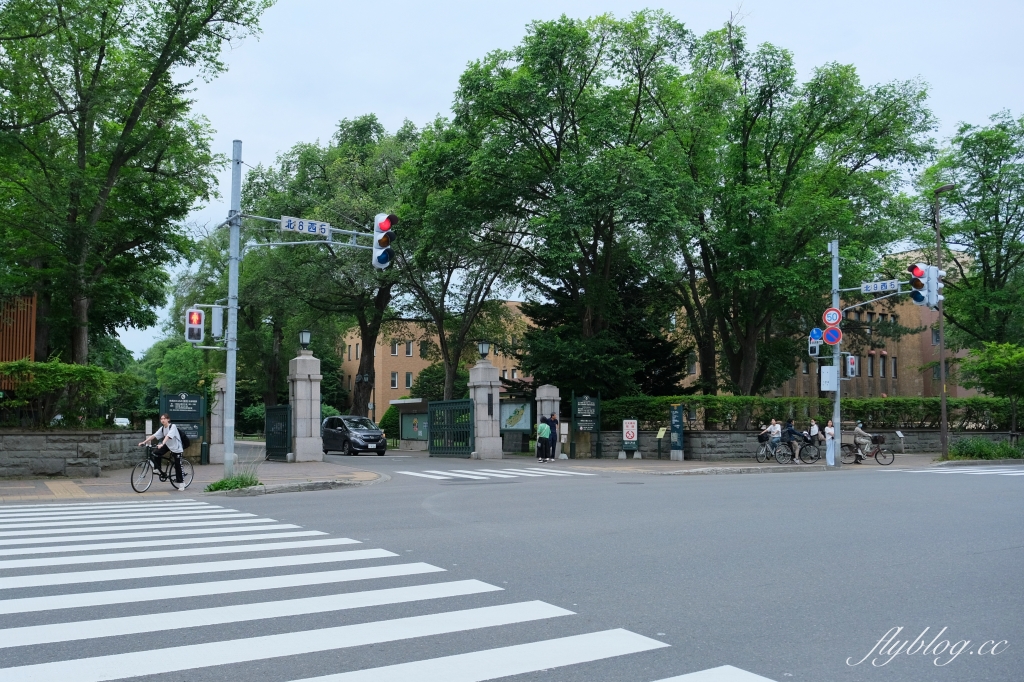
[920,112,1024,348]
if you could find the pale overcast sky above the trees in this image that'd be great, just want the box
[122,0,1024,353]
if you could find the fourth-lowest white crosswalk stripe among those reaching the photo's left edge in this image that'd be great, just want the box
[0,549,398,585]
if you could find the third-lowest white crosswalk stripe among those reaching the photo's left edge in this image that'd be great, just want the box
[0,562,444,614]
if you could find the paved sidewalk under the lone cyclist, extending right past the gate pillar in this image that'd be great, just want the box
[0,460,380,504]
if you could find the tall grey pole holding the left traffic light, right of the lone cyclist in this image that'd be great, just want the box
[224,139,242,478]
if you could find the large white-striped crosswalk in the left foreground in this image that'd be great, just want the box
[0,497,770,682]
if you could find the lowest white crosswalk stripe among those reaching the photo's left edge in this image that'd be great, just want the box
[0,601,577,682]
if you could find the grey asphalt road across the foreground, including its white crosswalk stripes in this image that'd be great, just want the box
[0,458,1024,682]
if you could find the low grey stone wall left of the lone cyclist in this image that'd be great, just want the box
[0,429,145,478]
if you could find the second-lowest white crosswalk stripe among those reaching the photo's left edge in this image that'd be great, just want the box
[0,581,502,647]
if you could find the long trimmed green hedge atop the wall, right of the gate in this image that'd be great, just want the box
[601,395,1010,431]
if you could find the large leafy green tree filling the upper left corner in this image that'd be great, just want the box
[0,0,270,364]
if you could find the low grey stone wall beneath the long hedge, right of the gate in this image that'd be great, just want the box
[591,429,1010,461]
